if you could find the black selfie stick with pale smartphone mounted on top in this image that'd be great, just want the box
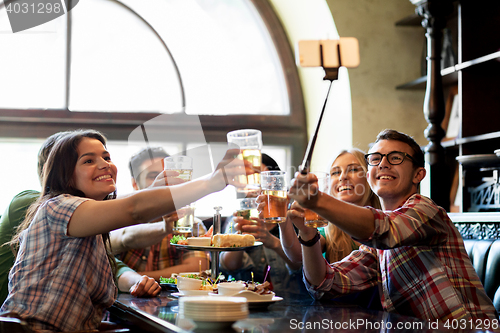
[298,37,359,175]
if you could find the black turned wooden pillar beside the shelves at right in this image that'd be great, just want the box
[411,0,453,211]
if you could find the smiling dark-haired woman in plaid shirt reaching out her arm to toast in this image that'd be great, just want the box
[1,130,252,331]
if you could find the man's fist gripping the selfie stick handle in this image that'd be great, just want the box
[288,172,321,209]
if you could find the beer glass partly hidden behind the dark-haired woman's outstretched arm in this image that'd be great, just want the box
[163,155,195,233]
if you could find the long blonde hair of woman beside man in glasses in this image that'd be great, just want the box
[325,148,381,262]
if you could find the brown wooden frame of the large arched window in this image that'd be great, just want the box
[0,0,307,166]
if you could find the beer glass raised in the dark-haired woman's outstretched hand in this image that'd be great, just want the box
[227,129,262,199]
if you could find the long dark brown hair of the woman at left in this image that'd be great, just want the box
[9,129,116,272]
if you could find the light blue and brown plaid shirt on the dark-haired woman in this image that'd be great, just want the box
[1,194,117,331]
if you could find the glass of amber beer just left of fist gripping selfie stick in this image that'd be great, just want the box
[261,171,288,223]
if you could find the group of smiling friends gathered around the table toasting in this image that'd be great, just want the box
[0,126,498,331]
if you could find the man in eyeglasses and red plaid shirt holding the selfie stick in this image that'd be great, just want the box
[289,130,498,329]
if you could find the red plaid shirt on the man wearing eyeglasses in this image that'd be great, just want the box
[304,194,497,322]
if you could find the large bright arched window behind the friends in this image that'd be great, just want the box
[0,0,306,215]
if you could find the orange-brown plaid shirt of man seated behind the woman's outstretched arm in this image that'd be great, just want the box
[117,223,207,273]
